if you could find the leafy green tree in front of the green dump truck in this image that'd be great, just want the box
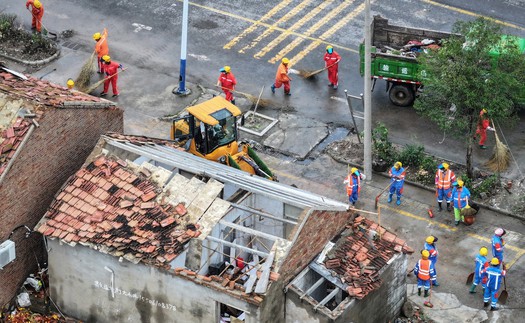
[414,18,525,178]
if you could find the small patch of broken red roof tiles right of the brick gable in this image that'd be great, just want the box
[324,216,413,299]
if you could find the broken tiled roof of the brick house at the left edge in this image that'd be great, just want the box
[0,63,114,181]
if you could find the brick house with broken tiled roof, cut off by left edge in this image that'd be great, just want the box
[0,63,123,305]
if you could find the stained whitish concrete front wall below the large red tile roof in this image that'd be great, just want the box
[49,240,259,323]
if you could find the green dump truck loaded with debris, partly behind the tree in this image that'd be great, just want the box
[359,16,525,106]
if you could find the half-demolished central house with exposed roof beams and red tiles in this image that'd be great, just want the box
[35,134,414,323]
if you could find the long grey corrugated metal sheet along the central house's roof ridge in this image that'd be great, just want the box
[104,137,348,211]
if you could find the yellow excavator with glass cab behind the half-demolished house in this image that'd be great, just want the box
[171,96,277,181]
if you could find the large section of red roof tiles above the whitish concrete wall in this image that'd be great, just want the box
[37,156,199,268]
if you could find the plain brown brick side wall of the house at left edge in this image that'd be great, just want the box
[0,108,123,305]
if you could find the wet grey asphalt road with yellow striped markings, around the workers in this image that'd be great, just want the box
[0,0,525,322]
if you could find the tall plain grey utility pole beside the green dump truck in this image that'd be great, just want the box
[363,0,372,180]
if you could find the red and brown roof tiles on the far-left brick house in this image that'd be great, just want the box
[0,68,114,175]
